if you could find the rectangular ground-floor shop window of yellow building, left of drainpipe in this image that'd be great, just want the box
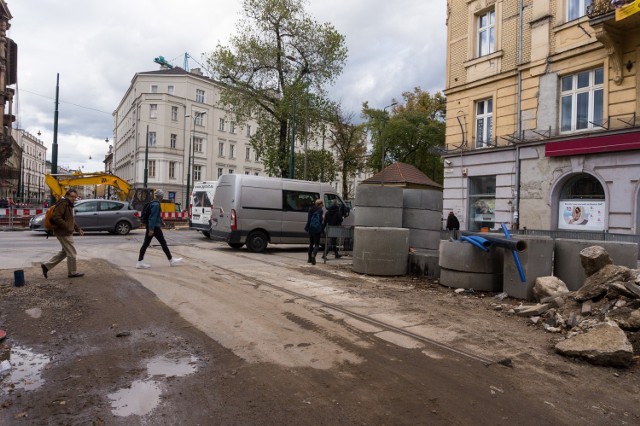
[469,176,496,231]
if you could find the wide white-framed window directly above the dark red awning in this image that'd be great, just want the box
[560,68,604,132]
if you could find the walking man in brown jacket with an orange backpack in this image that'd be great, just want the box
[40,189,84,278]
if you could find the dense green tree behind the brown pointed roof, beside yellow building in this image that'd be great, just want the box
[363,88,445,183]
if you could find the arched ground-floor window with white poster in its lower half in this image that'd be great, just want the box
[558,174,607,231]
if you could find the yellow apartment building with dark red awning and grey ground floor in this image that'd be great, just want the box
[443,0,640,234]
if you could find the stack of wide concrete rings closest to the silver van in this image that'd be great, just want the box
[353,185,409,276]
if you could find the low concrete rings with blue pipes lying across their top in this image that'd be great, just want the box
[440,240,506,292]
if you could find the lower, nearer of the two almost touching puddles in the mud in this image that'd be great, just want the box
[107,380,162,417]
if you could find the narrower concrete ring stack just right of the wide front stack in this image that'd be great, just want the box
[402,189,442,278]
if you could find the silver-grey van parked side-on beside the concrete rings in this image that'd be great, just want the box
[210,174,353,252]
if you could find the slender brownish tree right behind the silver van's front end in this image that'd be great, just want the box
[331,106,367,199]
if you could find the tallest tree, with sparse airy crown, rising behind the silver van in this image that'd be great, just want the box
[207,0,347,177]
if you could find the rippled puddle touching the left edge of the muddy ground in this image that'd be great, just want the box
[1,346,51,391]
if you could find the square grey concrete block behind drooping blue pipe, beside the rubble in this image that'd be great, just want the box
[503,235,554,300]
